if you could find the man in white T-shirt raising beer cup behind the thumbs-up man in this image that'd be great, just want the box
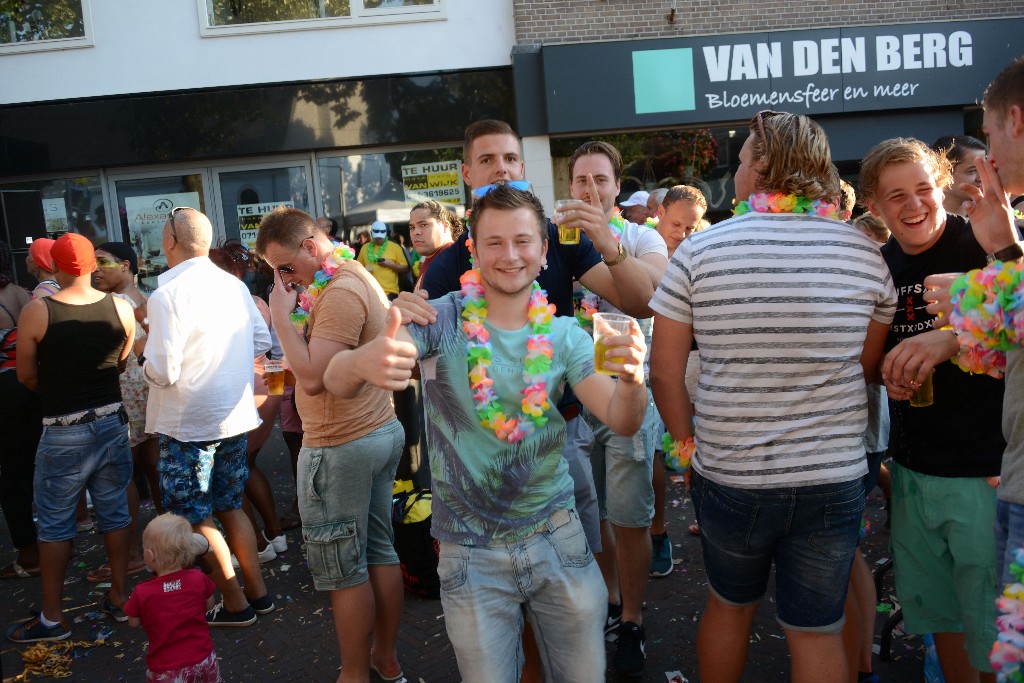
[569,141,669,676]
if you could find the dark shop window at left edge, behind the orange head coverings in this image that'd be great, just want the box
[0,175,107,245]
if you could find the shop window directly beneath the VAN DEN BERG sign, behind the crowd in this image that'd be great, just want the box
[551,125,746,217]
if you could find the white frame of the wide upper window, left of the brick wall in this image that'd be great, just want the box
[195,0,446,38]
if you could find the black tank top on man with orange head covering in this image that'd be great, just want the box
[38,294,127,417]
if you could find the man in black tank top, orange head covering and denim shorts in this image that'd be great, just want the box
[7,233,135,643]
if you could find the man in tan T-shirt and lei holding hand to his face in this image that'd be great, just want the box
[256,208,406,681]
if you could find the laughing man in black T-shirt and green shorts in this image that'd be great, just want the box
[860,138,1006,681]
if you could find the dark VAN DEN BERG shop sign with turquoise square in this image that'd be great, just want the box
[541,18,1024,133]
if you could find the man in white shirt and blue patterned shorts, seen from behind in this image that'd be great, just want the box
[144,207,273,627]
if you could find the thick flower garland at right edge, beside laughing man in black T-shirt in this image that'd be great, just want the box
[949,261,1024,378]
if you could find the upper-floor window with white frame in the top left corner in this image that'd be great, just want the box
[0,0,92,54]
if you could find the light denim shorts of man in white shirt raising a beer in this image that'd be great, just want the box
[586,389,662,528]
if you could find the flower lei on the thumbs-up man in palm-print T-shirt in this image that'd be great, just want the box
[459,239,555,443]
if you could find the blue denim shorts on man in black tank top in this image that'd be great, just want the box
[33,413,132,543]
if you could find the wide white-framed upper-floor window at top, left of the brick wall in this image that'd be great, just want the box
[197,0,443,36]
